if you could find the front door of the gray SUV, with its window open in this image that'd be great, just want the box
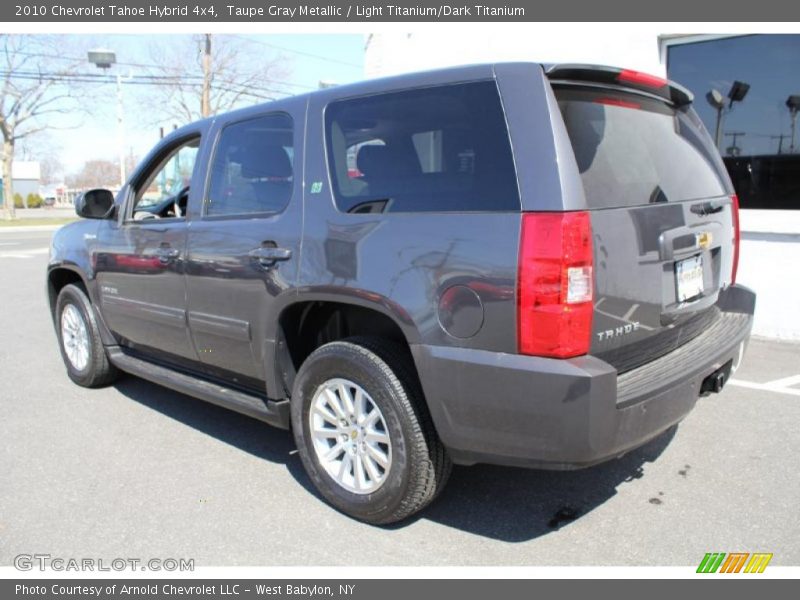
[96,134,200,363]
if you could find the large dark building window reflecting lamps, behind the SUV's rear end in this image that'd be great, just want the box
[667,35,800,209]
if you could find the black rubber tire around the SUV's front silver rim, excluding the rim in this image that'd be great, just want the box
[55,284,119,388]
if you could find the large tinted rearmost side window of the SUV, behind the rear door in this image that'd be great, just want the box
[325,81,519,212]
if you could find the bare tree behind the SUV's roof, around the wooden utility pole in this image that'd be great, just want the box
[147,34,290,124]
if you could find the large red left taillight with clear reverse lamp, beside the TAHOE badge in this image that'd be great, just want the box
[517,212,594,358]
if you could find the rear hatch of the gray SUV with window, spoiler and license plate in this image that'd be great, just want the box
[548,68,737,372]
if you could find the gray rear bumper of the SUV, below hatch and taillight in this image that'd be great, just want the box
[412,286,755,469]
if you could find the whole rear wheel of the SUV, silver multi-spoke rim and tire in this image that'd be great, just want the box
[292,337,451,524]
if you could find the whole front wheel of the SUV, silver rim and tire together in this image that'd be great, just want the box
[55,284,118,387]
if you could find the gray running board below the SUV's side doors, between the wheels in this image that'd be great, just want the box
[106,347,290,429]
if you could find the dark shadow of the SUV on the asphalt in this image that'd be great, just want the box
[115,376,677,543]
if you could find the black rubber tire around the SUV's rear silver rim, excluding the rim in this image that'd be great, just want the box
[291,337,452,525]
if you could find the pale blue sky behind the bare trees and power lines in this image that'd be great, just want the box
[18,34,365,178]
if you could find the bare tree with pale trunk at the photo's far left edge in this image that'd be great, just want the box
[0,34,80,219]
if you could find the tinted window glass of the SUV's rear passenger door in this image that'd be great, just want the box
[205,113,294,216]
